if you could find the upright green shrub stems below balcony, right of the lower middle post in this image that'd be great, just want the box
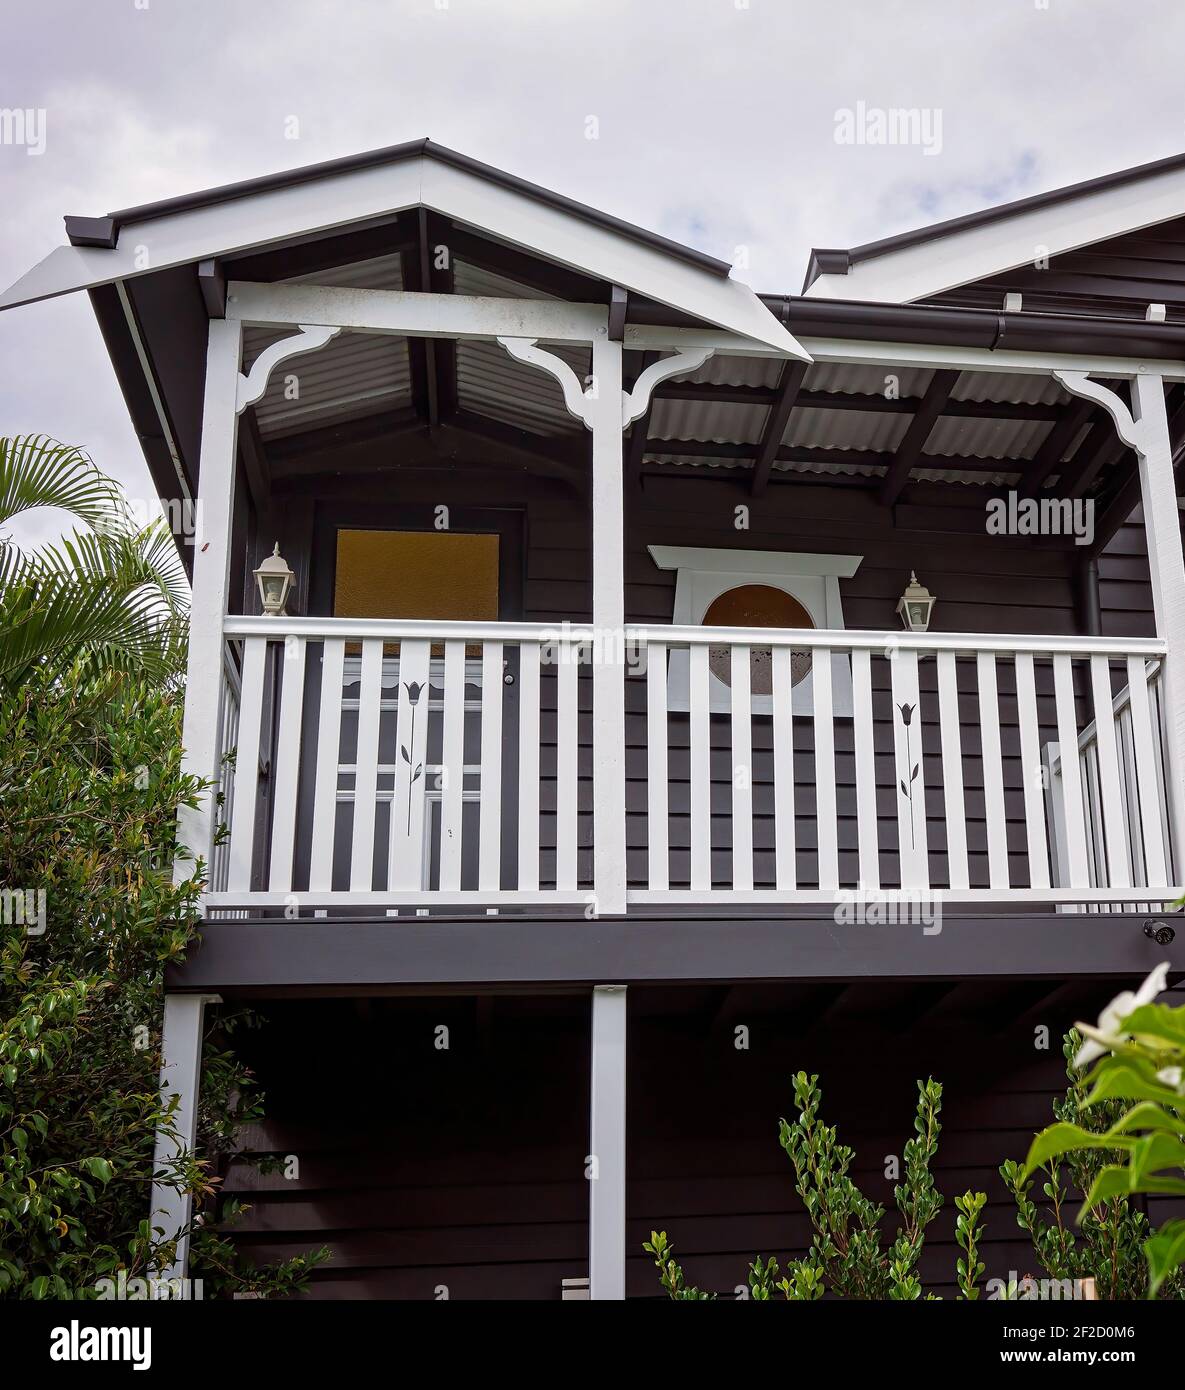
[643,1072,986,1301]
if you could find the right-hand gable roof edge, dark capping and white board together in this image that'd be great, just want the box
[803,154,1185,304]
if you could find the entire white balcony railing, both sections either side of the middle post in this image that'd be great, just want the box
[207,617,1181,913]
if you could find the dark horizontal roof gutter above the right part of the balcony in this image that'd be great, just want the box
[759,295,1185,361]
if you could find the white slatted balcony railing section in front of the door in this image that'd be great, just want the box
[207,619,592,909]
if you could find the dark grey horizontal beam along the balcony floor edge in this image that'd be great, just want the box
[165,912,1185,995]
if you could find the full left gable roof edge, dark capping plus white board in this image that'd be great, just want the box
[0,140,807,360]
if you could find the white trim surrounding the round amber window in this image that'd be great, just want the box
[647,545,864,719]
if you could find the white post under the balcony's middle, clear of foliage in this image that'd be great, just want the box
[589,984,625,1300]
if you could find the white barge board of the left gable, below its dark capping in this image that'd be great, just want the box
[0,144,810,361]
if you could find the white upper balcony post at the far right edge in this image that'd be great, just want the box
[1132,373,1185,883]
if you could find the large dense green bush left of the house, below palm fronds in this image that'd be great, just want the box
[0,663,320,1298]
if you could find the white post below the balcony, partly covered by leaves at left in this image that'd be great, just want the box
[150,994,217,1279]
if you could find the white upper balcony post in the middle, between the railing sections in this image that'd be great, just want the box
[589,329,627,917]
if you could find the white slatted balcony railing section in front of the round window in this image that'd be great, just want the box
[631,627,1179,904]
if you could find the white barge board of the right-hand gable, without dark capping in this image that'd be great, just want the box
[806,168,1185,304]
